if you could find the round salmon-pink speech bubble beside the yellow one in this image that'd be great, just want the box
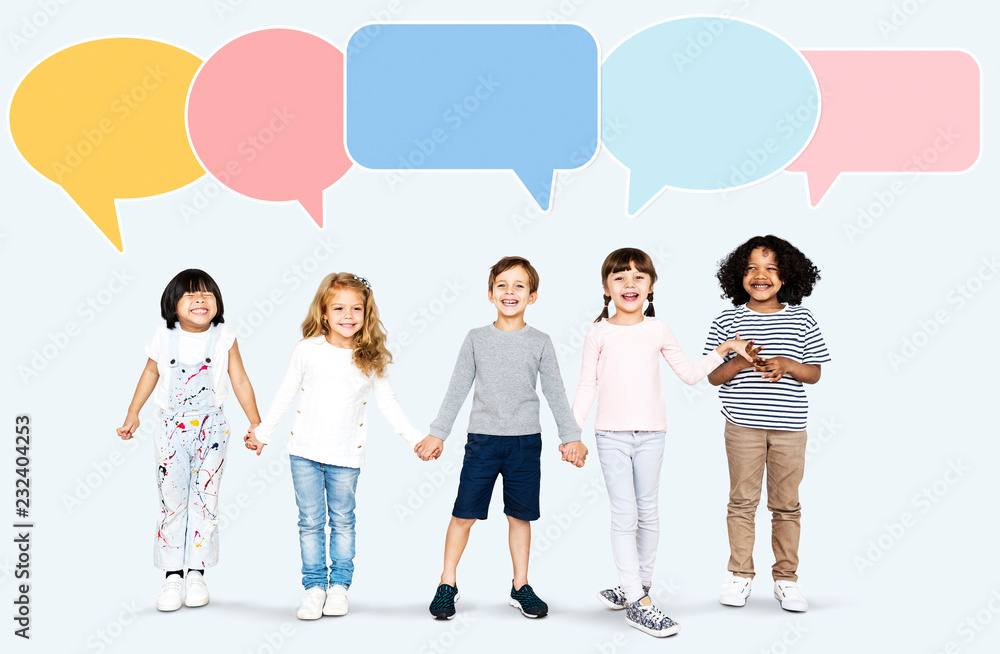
[187,29,351,227]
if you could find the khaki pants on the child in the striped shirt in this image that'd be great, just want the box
[725,420,806,581]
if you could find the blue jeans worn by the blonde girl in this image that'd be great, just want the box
[288,455,361,590]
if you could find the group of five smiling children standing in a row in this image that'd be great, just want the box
[118,236,829,637]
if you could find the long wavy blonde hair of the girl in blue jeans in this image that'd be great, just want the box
[302,273,392,377]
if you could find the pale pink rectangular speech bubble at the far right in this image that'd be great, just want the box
[786,50,981,207]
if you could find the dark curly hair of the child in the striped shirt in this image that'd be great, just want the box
[715,234,819,307]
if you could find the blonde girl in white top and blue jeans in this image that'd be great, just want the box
[250,273,423,620]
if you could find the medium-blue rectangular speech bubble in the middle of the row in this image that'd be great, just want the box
[345,24,600,211]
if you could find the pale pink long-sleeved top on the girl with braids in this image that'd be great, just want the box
[573,317,722,431]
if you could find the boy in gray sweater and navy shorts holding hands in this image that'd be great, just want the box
[416,257,587,619]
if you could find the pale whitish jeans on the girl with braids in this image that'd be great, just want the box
[596,431,665,602]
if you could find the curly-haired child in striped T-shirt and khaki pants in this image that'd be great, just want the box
[705,235,830,611]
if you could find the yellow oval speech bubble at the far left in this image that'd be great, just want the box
[10,38,205,252]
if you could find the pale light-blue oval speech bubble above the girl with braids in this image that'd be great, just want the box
[601,16,820,215]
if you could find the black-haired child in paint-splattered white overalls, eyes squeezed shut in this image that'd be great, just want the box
[117,268,260,611]
